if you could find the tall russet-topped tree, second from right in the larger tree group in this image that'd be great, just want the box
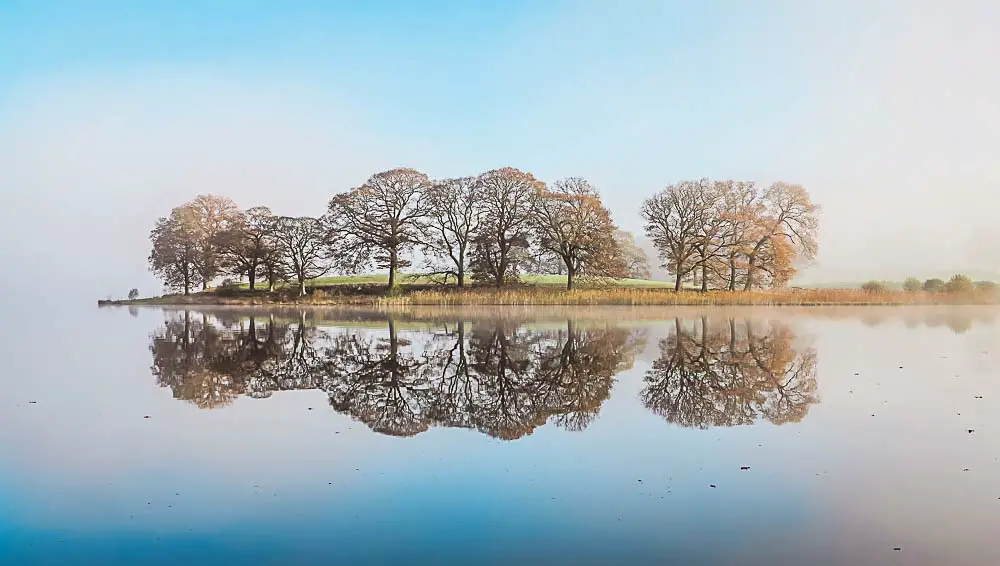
[472,167,545,287]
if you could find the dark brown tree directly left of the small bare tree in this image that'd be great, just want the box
[222,206,275,291]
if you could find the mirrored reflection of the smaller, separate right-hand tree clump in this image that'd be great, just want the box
[640,317,816,428]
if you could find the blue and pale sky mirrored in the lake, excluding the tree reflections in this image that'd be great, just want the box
[0,311,1000,564]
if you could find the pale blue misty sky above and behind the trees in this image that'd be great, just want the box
[0,0,1000,299]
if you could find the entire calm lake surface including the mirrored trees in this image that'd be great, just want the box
[0,307,1000,566]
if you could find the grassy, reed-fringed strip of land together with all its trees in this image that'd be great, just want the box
[105,167,998,306]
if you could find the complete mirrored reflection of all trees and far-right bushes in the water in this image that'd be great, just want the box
[150,310,992,440]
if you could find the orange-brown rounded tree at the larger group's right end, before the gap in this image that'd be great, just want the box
[534,177,626,290]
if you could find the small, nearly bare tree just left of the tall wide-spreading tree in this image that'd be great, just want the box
[273,216,330,297]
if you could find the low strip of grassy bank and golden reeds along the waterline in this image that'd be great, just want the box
[97,287,998,307]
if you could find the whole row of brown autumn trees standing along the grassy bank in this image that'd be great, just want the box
[149,167,818,295]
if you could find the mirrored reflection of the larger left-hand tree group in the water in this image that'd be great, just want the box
[150,312,645,440]
